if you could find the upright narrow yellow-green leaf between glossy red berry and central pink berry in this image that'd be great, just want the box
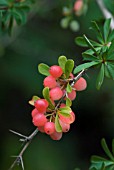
[43,87,55,109]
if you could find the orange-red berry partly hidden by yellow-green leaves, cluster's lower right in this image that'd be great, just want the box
[59,111,75,124]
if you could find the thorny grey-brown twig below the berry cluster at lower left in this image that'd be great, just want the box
[9,128,38,170]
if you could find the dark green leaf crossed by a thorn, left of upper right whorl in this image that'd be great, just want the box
[75,37,101,47]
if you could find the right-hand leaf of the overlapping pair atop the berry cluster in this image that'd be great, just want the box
[65,59,74,78]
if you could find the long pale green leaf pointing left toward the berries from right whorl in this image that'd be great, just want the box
[74,61,100,74]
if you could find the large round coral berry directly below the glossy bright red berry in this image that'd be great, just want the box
[33,114,47,126]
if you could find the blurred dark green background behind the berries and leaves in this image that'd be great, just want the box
[0,0,114,170]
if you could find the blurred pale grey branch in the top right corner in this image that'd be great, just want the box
[96,0,114,29]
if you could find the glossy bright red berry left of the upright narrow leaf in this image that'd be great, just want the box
[34,99,49,113]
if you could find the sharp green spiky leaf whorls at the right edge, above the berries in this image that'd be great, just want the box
[74,18,114,89]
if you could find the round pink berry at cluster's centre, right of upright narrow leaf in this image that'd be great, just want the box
[49,87,63,100]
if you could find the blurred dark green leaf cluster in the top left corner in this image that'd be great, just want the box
[0,0,34,35]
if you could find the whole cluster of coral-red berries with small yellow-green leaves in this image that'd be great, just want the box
[30,56,87,140]
